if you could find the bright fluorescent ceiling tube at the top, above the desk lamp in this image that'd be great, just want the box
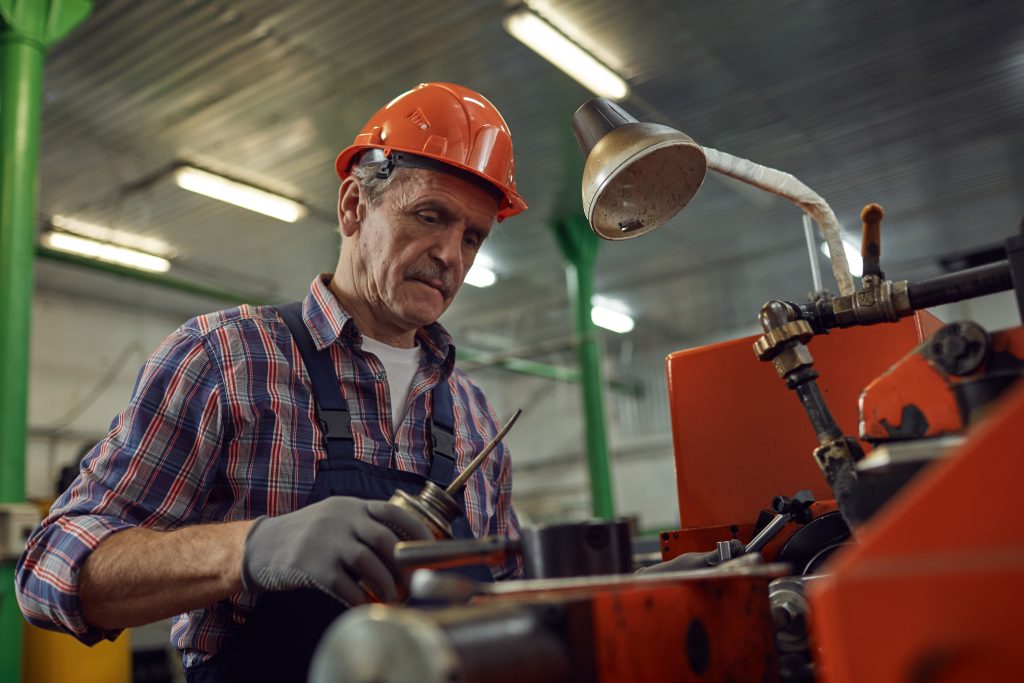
[505,8,630,99]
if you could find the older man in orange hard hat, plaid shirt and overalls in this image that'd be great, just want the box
[17,83,526,681]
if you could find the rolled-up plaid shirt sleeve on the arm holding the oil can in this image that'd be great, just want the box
[15,327,223,644]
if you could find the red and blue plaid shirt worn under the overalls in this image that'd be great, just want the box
[17,275,521,667]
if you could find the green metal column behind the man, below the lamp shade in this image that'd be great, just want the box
[554,215,615,519]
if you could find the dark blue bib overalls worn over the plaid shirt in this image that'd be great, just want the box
[185,302,493,683]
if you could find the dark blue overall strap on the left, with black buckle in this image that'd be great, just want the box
[276,301,355,459]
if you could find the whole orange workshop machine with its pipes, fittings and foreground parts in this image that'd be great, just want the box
[312,204,1024,683]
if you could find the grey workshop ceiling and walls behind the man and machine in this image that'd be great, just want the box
[2,0,1024,679]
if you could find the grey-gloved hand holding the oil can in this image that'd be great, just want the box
[242,496,433,606]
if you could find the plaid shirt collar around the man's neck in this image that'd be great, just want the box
[302,273,455,377]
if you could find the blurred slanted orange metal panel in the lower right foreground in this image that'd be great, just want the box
[810,362,1024,683]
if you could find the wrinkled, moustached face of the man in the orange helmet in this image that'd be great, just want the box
[356,169,498,330]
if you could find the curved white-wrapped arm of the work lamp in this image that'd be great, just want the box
[703,147,854,296]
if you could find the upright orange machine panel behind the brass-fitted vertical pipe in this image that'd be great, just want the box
[662,312,942,560]
